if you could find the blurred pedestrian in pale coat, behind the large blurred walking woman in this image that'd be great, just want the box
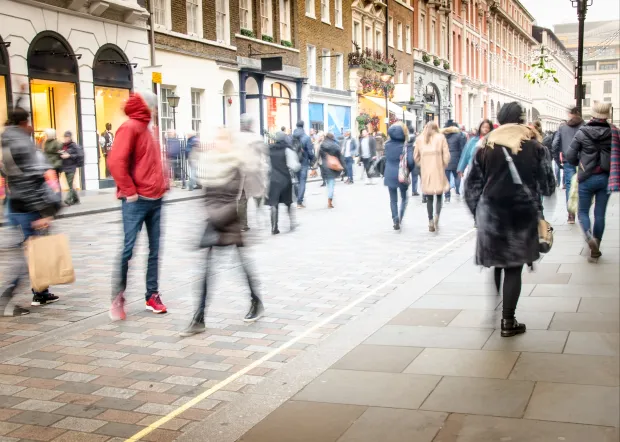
[234,114,269,232]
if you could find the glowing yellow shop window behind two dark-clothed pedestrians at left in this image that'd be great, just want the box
[30,79,82,190]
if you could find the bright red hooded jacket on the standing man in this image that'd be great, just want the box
[108,94,168,199]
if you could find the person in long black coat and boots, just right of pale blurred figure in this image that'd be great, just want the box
[266,132,295,235]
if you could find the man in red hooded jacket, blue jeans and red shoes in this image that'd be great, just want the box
[108,92,168,320]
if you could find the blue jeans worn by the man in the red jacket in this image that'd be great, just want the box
[112,198,163,301]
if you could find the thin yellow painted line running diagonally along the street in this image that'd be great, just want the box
[125,229,476,442]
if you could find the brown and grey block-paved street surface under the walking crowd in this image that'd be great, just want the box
[0,178,480,442]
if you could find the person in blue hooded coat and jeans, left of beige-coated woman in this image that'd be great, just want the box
[383,123,413,230]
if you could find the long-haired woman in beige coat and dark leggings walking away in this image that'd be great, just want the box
[413,121,450,232]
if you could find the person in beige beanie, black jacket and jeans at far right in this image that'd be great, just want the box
[566,101,612,261]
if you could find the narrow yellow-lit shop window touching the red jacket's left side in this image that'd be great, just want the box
[95,86,129,179]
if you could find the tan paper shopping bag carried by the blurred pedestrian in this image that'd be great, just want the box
[26,235,75,292]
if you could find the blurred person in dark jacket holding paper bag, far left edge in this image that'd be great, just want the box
[0,100,61,316]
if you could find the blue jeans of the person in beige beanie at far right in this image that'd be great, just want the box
[576,174,609,240]
